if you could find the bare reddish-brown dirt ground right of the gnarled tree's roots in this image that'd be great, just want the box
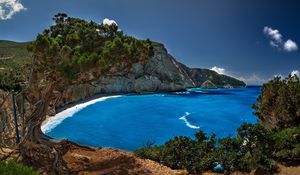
[63,144,187,175]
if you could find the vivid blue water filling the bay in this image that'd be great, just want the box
[46,87,260,151]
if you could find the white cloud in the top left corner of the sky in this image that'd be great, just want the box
[0,0,26,20]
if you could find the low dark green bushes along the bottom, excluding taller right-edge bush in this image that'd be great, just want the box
[135,124,287,174]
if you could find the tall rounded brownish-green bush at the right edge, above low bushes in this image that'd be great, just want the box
[253,75,300,129]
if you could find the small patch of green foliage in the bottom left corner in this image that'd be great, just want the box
[0,160,38,175]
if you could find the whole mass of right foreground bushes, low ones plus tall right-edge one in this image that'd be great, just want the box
[135,76,300,174]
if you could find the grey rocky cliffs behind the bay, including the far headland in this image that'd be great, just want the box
[60,43,245,105]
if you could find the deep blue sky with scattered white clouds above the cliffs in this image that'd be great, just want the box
[0,0,300,84]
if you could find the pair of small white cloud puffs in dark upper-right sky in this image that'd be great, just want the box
[263,26,298,52]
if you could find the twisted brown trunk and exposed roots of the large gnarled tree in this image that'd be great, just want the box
[19,83,68,174]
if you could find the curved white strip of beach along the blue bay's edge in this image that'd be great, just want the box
[41,95,121,133]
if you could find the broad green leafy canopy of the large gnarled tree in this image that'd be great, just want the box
[28,13,153,79]
